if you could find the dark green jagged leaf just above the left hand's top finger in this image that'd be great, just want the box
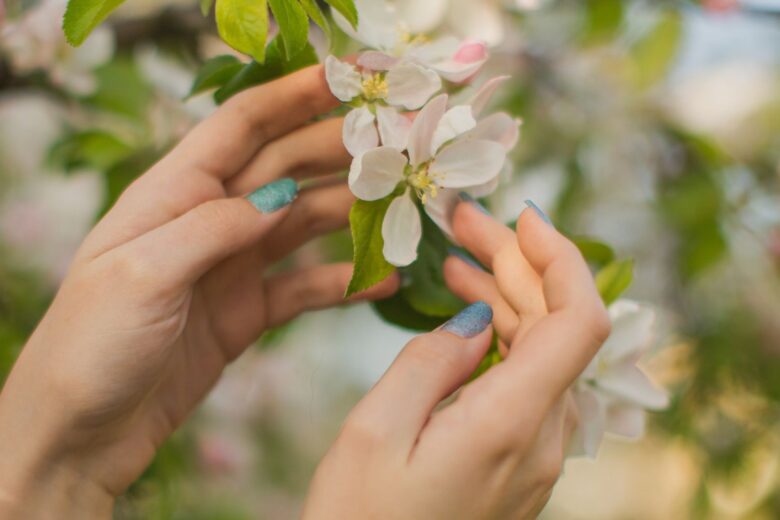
[214,36,318,104]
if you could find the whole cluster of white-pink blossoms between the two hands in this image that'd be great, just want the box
[325,2,519,267]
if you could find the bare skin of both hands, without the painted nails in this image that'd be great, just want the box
[0,67,609,519]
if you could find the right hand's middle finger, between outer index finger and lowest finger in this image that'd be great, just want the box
[453,202,546,318]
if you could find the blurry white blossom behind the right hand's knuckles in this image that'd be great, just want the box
[569,300,668,457]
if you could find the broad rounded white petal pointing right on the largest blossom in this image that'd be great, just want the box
[431,141,506,188]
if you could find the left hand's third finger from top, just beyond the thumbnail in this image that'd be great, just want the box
[260,183,355,263]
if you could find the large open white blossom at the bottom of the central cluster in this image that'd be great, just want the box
[349,94,507,266]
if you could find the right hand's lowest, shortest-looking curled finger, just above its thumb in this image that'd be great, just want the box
[444,256,520,343]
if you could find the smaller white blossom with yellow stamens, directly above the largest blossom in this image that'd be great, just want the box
[325,56,441,157]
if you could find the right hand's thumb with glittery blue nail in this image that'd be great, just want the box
[345,302,493,449]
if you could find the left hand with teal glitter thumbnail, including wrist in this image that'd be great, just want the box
[0,67,397,518]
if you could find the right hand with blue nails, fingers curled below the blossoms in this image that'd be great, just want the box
[304,204,610,520]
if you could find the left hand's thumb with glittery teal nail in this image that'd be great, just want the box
[116,179,298,287]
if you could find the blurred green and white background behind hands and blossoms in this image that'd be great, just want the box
[0,0,780,520]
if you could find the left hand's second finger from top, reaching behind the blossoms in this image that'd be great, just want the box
[225,118,351,195]
